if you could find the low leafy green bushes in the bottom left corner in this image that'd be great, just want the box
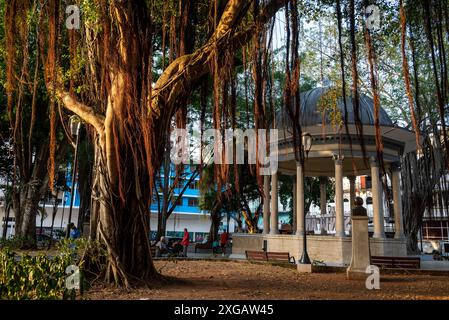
[0,238,106,300]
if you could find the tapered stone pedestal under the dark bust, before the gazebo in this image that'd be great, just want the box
[346,216,370,280]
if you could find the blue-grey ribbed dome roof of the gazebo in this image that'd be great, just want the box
[276,87,394,129]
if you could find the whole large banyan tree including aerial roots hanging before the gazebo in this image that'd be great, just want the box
[5,0,449,286]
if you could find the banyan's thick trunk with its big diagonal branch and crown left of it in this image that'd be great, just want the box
[6,0,287,286]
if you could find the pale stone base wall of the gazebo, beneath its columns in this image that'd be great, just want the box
[232,233,407,266]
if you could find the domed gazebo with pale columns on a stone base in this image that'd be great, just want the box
[233,87,416,265]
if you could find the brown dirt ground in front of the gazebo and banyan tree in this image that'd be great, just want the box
[86,260,449,300]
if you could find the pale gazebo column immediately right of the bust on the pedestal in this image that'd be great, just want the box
[370,158,385,238]
